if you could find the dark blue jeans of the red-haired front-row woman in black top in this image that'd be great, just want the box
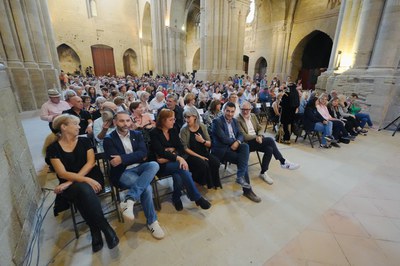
[160,162,201,202]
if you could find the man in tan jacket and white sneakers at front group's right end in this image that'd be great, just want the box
[237,101,300,185]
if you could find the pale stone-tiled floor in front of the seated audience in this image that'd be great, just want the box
[23,112,400,266]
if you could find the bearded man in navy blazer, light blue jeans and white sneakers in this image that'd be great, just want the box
[103,111,164,239]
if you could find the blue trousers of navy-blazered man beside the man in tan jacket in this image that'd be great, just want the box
[222,143,250,184]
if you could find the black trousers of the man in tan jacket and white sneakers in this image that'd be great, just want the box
[247,137,283,174]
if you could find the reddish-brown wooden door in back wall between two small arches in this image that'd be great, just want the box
[91,44,115,76]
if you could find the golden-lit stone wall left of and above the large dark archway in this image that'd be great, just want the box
[244,0,340,80]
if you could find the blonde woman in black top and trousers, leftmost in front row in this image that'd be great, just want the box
[45,114,119,252]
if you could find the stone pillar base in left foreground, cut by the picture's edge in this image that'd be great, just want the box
[0,64,40,265]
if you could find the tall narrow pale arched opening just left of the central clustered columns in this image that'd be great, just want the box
[141,2,154,73]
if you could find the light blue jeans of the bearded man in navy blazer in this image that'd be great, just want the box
[119,162,160,224]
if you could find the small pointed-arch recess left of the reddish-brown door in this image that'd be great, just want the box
[57,43,81,74]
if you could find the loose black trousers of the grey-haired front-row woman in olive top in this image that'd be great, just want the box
[187,154,222,188]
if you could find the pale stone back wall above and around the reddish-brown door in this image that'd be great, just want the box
[48,0,143,75]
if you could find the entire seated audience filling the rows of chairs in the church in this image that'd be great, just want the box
[41,70,373,251]
